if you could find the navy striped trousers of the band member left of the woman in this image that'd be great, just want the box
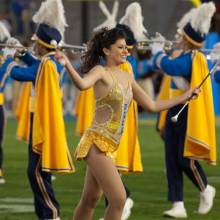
[27,114,60,220]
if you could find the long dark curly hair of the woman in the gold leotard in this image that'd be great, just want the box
[81,28,126,73]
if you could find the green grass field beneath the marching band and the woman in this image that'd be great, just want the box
[0,120,220,220]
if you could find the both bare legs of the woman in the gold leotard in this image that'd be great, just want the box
[74,146,126,220]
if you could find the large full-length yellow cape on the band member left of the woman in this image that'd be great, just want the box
[32,54,74,173]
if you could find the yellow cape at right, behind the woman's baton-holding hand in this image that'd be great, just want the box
[184,51,216,165]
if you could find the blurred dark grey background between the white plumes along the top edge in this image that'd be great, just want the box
[0,0,205,44]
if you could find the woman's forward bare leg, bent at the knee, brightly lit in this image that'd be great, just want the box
[86,146,126,220]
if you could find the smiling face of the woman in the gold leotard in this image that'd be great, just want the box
[103,38,128,65]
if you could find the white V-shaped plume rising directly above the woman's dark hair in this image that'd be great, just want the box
[93,1,119,31]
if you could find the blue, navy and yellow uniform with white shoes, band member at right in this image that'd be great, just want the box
[154,2,216,218]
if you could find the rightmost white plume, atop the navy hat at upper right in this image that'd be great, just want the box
[190,2,216,35]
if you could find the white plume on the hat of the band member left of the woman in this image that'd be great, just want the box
[32,0,68,36]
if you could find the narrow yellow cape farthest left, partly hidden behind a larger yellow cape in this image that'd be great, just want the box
[15,82,32,142]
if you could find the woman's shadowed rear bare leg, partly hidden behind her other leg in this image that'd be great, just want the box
[73,166,102,220]
